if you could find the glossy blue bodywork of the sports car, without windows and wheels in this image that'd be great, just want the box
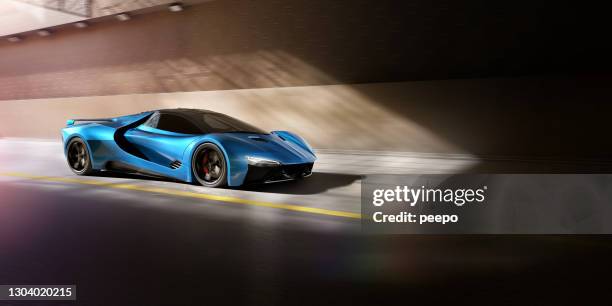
[62,111,316,186]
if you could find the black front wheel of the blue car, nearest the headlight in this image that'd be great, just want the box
[191,143,227,188]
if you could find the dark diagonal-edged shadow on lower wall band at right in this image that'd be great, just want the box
[356,75,612,160]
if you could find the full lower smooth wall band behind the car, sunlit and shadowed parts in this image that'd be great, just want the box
[0,77,612,159]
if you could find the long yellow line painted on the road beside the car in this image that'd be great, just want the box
[1,172,362,219]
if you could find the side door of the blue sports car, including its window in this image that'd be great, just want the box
[125,112,200,169]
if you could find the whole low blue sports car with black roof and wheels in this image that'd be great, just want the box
[62,109,316,187]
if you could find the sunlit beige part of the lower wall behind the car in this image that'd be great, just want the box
[0,84,458,152]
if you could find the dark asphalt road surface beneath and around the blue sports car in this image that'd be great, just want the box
[0,139,612,305]
